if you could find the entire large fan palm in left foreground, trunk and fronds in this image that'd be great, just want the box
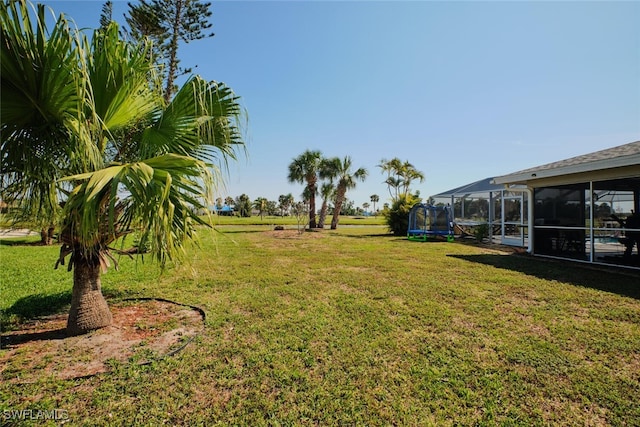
[0,0,244,335]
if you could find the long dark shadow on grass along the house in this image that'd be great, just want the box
[447,254,640,300]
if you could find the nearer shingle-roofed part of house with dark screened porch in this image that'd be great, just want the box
[491,141,640,268]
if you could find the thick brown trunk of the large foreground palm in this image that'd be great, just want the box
[67,254,113,336]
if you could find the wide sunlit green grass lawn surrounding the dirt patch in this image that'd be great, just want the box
[0,227,640,426]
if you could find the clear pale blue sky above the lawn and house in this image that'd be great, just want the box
[45,1,640,210]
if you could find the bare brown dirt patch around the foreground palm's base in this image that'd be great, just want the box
[0,300,204,383]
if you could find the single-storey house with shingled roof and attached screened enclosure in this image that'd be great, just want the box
[432,141,640,268]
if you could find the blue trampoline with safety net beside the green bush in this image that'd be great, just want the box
[407,203,453,242]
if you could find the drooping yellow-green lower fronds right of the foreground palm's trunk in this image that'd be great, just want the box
[59,154,211,264]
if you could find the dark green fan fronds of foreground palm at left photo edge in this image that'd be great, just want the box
[0,1,84,227]
